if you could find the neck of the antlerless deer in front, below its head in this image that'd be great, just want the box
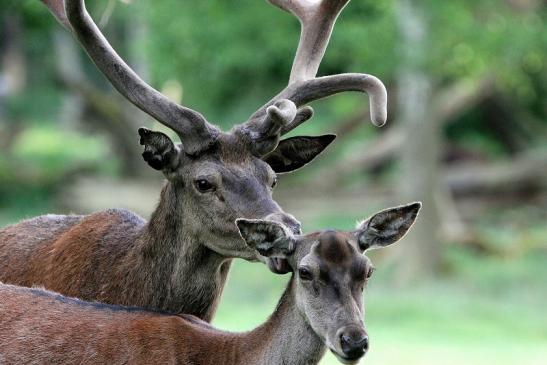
[241,278,326,365]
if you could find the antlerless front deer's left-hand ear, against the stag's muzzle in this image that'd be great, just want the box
[236,218,295,258]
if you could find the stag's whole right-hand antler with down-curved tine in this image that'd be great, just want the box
[241,0,387,155]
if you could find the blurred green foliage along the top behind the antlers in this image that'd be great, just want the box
[0,0,547,126]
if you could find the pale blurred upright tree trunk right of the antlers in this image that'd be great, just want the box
[397,0,441,282]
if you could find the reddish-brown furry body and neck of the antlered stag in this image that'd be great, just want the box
[0,185,231,320]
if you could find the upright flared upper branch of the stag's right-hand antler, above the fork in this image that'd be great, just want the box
[268,0,349,85]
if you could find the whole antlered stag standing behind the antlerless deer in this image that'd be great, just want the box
[0,0,386,321]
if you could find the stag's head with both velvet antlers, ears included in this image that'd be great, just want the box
[42,0,387,271]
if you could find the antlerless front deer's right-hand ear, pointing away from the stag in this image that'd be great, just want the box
[355,202,422,251]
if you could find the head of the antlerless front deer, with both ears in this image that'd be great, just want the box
[237,203,421,363]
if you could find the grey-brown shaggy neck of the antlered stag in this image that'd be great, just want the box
[121,182,231,321]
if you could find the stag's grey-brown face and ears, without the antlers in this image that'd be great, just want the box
[139,128,334,262]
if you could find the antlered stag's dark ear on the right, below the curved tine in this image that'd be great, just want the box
[263,134,336,173]
